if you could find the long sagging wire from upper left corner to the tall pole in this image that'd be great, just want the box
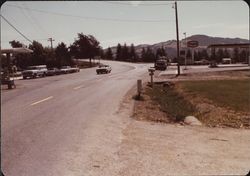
[6,5,174,22]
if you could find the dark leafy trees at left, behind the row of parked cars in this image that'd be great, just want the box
[1,33,102,69]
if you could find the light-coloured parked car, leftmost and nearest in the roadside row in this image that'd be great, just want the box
[22,65,48,79]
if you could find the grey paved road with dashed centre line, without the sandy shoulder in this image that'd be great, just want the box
[1,62,149,176]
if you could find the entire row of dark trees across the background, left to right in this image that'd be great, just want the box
[1,33,249,68]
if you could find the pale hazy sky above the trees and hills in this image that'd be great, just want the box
[1,0,249,48]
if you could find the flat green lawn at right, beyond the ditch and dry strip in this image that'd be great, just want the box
[179,79,250,113]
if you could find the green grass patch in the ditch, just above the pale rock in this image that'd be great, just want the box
[145,85,196,122]
